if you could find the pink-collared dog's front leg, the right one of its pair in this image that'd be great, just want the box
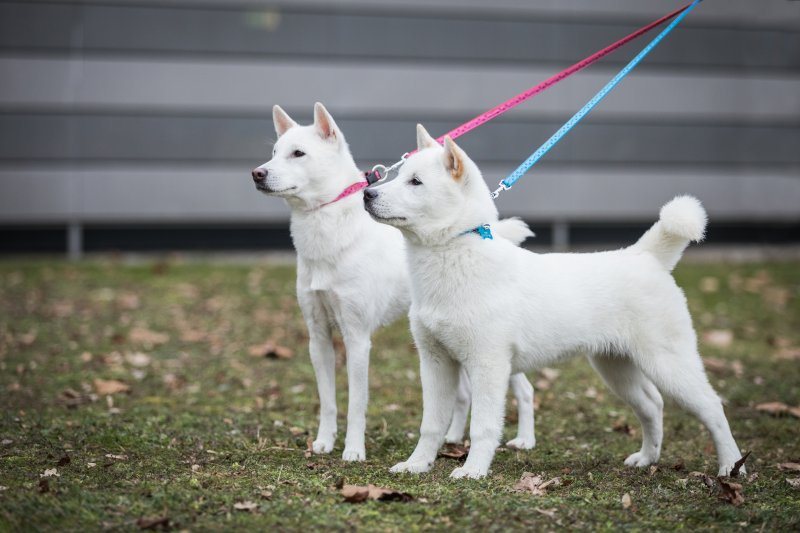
[342,328,371,461]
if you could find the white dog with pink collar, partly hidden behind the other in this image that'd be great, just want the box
[252,103,535,461]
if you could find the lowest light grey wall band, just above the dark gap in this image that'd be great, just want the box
[0,165,800,223]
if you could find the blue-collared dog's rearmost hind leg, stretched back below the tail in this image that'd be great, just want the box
[642,350,745,476]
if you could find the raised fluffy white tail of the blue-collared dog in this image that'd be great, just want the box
[633,196,708,271]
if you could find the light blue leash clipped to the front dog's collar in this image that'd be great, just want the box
[492,0,702,198]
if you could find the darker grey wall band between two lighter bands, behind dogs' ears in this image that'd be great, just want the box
[0,113,800,166]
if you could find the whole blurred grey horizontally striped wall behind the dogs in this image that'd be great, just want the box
[0,0,800,253]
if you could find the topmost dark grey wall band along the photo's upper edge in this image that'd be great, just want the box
[0,3,800,70]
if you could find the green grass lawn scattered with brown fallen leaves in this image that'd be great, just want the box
[0,260,800,531]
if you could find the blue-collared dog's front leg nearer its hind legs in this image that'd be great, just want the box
[450,355,511,479]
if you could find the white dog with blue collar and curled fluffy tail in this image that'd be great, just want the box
[364,126,741,478]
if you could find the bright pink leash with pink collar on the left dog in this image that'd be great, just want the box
[320,2,692,208]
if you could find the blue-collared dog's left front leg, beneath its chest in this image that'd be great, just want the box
[391,335,458,473]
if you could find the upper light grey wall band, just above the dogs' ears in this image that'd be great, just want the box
[0,57,800,125]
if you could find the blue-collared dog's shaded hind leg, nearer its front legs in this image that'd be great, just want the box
[589,355,664,466]
